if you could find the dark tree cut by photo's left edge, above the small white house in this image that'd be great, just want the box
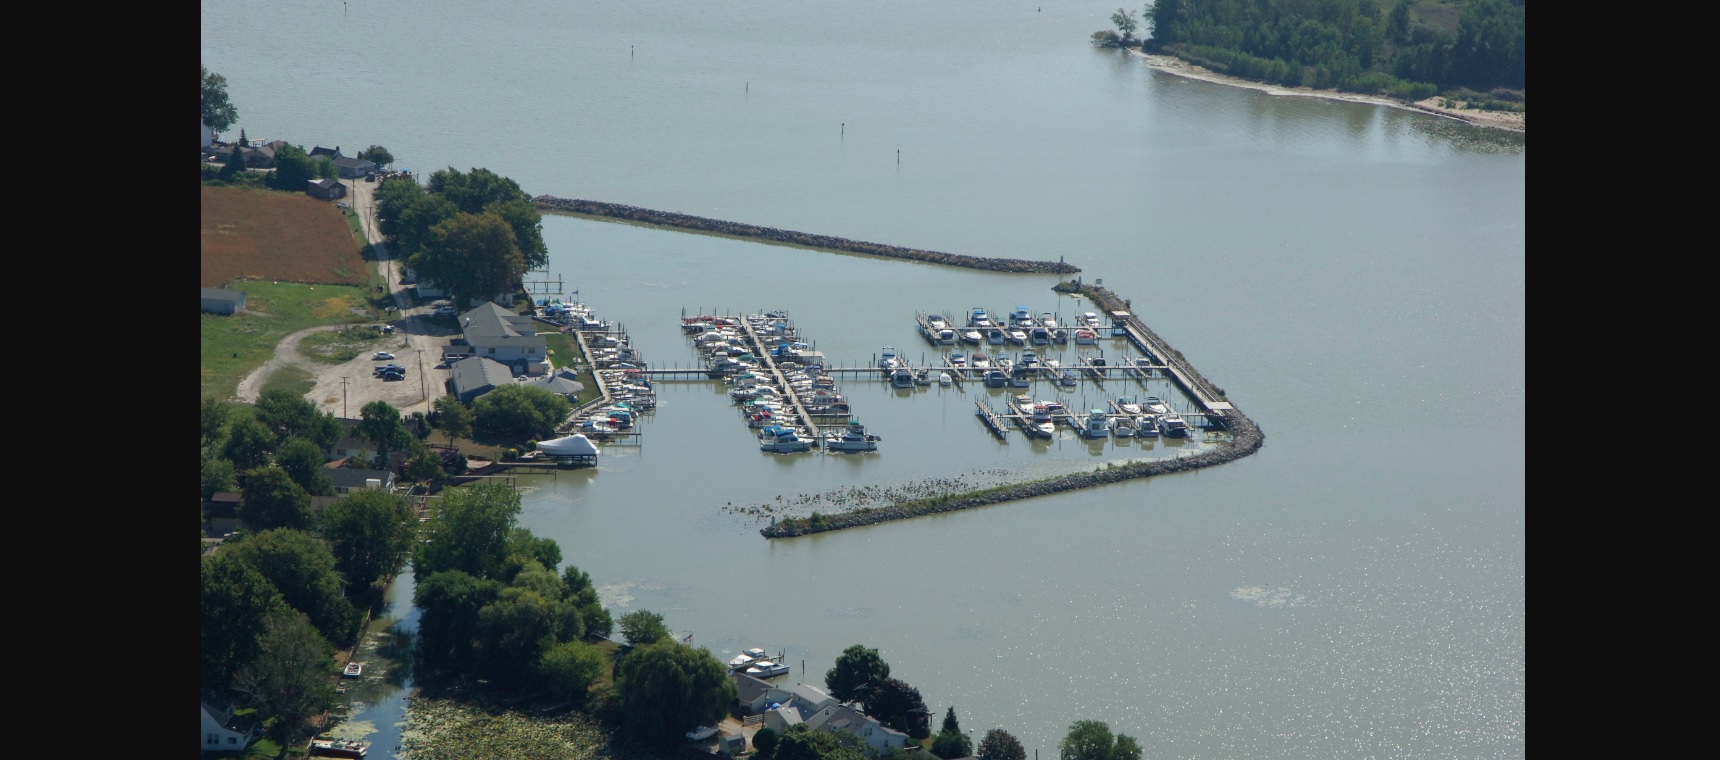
[198,552,286,691]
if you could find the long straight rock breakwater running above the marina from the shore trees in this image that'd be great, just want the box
[531,196,1080,275]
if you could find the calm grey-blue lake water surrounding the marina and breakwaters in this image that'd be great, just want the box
[201,0,1527,758]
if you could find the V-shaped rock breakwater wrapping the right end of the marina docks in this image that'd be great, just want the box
[759,284,1266,538]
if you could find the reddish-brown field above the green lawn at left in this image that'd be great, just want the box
[203,187,370,287]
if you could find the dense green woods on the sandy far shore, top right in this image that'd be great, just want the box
[1094,0,1527,100]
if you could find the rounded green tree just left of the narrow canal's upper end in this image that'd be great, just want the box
[318,488,418,588]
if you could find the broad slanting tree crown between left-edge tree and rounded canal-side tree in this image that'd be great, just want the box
[222,528,359,647]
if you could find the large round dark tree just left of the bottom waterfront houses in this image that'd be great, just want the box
[616,638,734,748]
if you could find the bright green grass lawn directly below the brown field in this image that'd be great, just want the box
[201,280,382,399]
